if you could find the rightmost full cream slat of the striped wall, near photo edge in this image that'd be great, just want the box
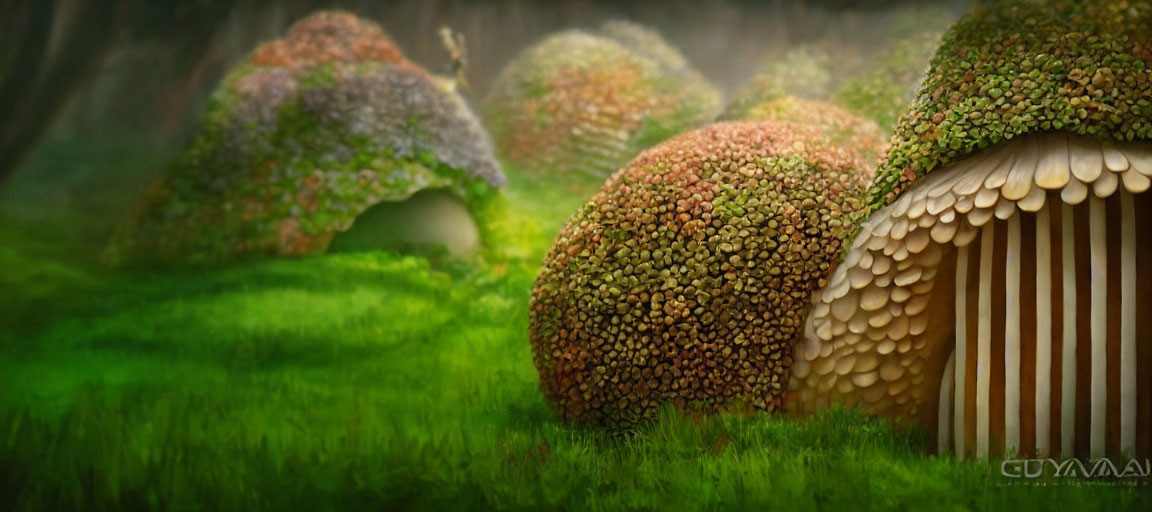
[1120,191,1136,451]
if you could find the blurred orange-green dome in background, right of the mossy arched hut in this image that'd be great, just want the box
[484,22,721,179]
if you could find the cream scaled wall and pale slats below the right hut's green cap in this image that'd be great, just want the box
[789,134,1152,455]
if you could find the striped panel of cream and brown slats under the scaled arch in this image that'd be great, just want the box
[938,193,1152,459]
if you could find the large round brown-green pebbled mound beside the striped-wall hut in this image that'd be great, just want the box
[530,122,867,426]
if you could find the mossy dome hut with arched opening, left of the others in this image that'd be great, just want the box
[107,12,505,264]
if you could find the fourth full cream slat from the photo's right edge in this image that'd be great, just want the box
[1034,205,1052,457]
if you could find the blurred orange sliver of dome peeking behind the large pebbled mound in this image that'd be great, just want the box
[730,96,887,169]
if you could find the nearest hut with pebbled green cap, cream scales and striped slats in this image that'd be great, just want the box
[789,1,1152,458]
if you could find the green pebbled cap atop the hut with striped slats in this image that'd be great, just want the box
[869,0,1152,210]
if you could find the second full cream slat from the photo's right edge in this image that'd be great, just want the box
[1087,195,1108,459]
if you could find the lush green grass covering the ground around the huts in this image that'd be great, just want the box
[0,137,1152,510]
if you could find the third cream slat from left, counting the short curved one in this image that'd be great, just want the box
[976,223,996,458]
